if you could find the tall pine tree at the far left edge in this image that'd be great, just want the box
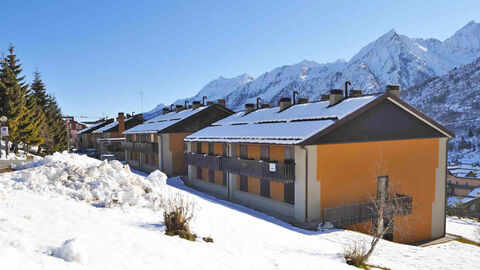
[0,45,28,154]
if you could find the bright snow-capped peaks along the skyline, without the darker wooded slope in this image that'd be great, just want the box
[149,21,480,110]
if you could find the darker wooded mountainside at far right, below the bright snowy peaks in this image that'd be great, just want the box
[402,58,480,161]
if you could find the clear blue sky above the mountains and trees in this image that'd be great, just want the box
[0,0,480,120]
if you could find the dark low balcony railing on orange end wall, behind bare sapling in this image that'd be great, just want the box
[323,194,412,227]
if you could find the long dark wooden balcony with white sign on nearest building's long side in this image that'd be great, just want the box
[185,153,295,183]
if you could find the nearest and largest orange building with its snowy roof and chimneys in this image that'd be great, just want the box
[185,86,454,243]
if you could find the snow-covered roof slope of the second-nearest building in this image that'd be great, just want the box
[123,105,211,134]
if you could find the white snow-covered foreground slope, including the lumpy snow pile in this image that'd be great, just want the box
[0,154,480,270]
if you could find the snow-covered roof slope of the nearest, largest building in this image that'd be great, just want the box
[185,95,379,144]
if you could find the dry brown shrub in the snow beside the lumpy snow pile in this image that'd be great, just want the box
[163,193,197,241]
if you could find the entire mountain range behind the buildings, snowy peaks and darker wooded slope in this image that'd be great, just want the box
[144,21,480,160]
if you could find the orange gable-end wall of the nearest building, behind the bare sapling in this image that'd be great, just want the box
[317,138,439,242]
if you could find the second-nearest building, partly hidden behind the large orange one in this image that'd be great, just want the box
[123,100,233,176]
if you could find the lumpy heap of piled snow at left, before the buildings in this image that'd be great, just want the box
[0,152,167,208]
